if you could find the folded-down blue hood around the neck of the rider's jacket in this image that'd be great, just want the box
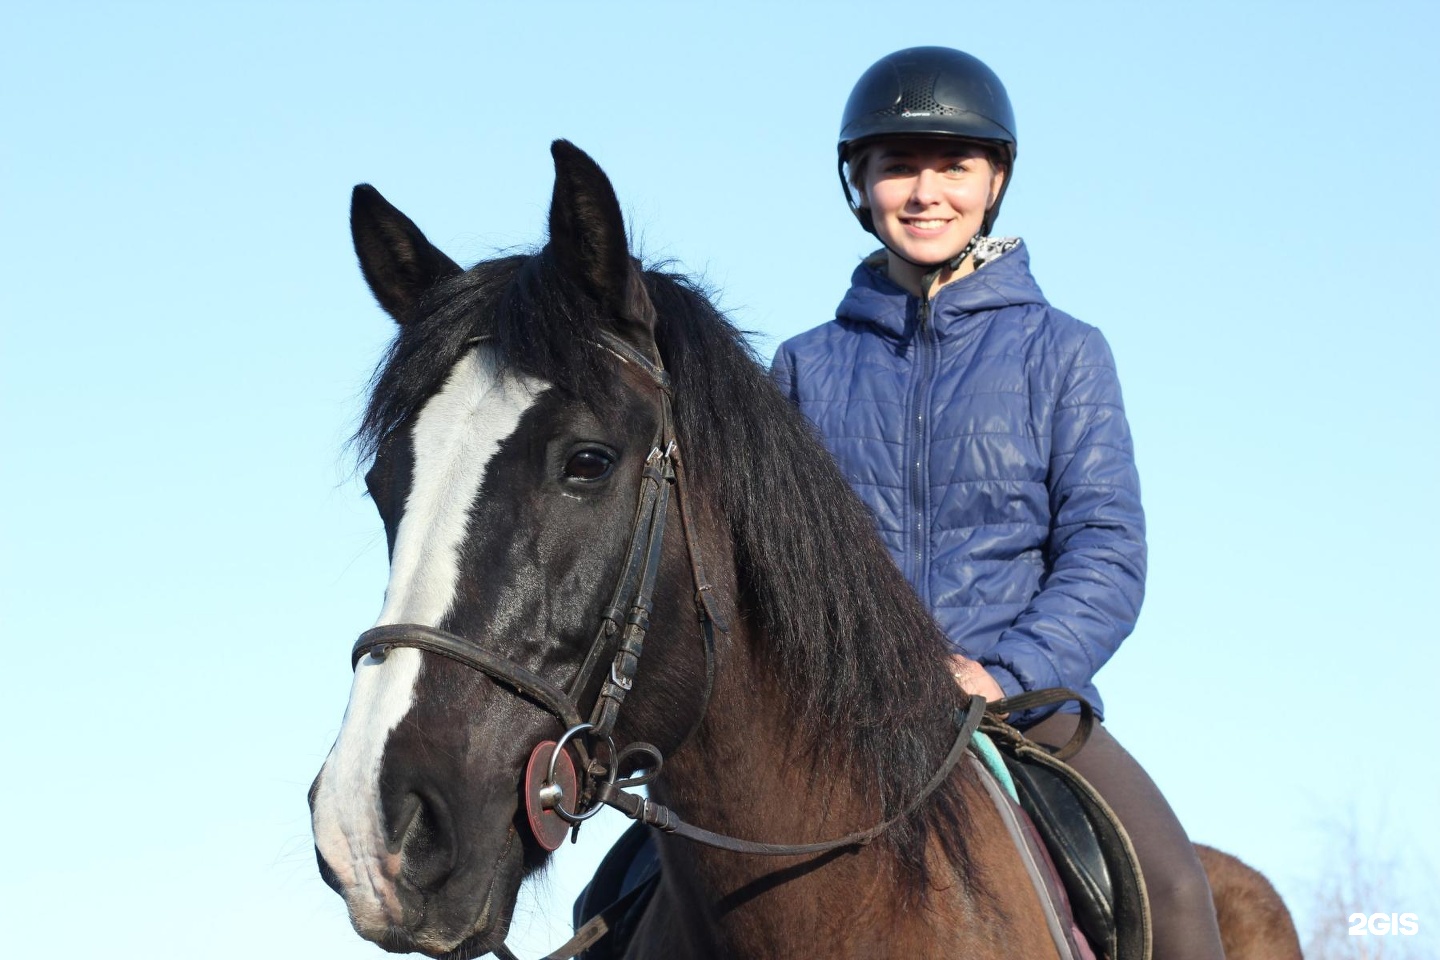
[835,242,1045,338]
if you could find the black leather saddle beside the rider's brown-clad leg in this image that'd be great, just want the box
[979,688,1151,960]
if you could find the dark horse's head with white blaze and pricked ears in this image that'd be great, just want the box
[311,141,720,956]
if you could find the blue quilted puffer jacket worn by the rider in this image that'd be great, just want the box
[772,245,1145,727]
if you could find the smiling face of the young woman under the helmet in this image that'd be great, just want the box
[860,140,1005,285]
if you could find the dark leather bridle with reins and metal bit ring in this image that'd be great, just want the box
[350,331,985,957]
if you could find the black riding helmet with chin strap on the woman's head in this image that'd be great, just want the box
[837,46,1017,247]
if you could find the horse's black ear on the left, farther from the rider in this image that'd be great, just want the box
[350,183,461,325]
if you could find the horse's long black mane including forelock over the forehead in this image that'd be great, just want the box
[354,252,969,889]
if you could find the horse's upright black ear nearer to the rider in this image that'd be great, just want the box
[550,140,655,354]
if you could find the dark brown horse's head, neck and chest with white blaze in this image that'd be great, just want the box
[310,141,1299,960]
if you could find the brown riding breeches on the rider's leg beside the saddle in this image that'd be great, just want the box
[1025,714,1225,960]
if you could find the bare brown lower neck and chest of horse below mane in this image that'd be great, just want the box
[641,628,1048,957]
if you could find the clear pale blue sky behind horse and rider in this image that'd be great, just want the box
[0,3,1440,957]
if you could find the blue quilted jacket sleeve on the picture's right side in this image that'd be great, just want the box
[981,328,1146,725]
